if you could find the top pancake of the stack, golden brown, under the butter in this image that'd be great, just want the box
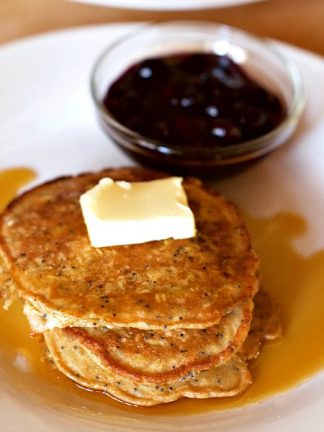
[0,168,258,329]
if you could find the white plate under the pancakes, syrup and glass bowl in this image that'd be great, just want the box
[0,25,324,432]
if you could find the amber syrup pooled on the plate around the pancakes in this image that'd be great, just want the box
[0,169,324,416]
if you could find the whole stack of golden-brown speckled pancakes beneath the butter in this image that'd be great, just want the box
[0,168,280,406]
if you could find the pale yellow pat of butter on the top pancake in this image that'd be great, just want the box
[80,177,195,247]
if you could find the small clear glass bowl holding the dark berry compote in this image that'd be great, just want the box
[91,21,304,174]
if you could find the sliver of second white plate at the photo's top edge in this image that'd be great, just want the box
[72,0,262,10]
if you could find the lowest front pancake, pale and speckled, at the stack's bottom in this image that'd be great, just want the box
[44,329,251,406]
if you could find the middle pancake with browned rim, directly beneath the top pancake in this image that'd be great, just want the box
[40,304,252,383]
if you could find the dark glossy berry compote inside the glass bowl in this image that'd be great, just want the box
[103,53,286,148]
